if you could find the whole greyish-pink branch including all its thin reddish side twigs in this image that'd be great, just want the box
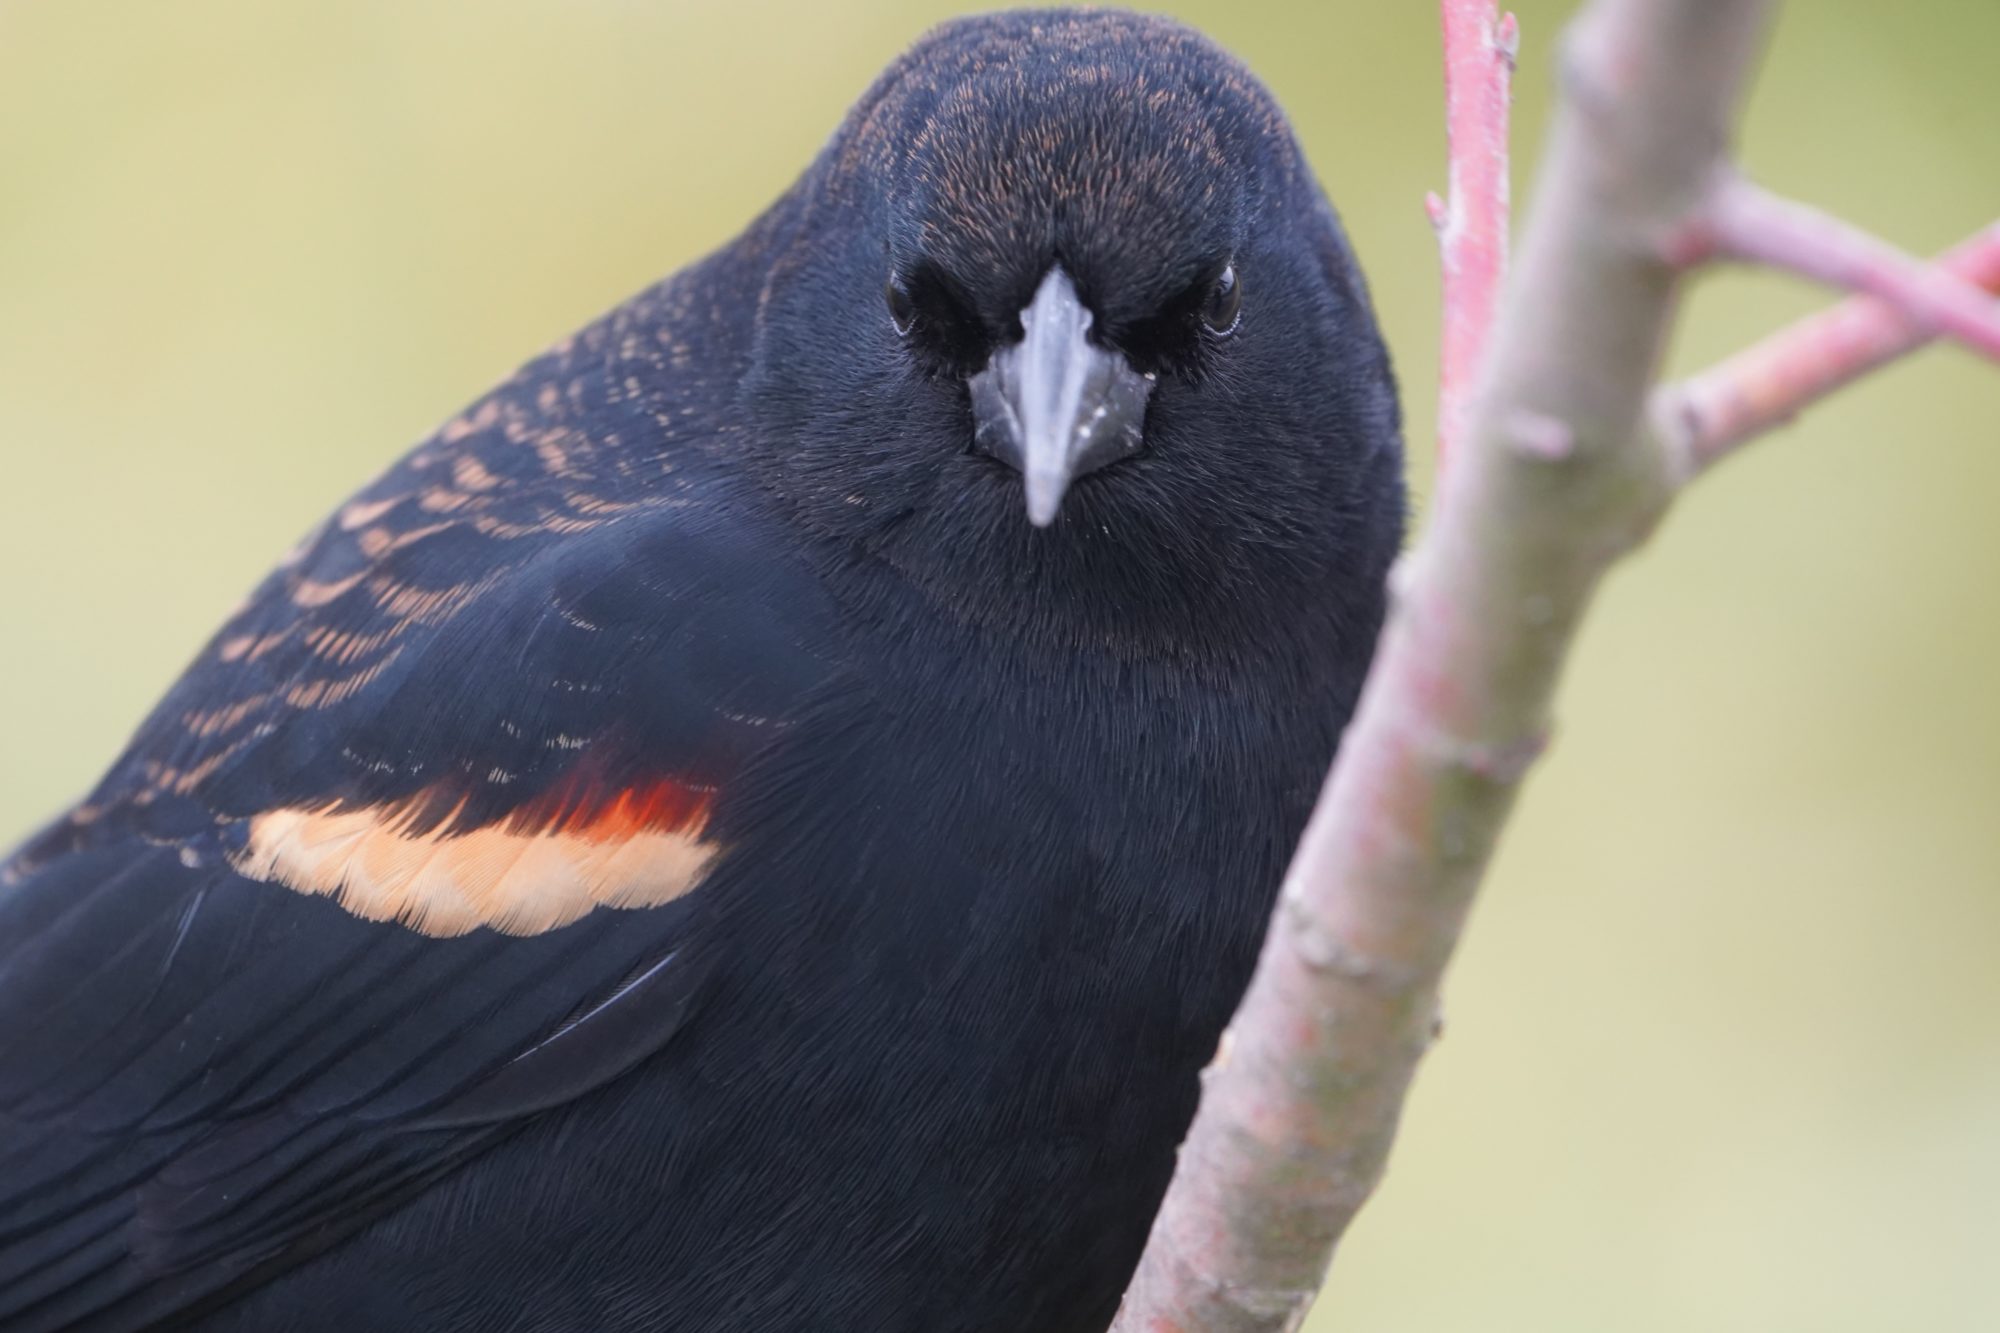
[1112,0,2000,1333]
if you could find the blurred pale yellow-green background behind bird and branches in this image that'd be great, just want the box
[0,0,2000,1333]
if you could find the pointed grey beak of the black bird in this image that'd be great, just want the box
[972,268,1154,528]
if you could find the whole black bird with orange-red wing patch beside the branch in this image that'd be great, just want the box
[0,12,1404,1333]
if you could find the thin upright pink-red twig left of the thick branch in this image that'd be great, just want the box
[1426,0,1520,466]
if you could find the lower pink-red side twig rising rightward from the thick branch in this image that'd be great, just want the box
[1654,222,2000,466]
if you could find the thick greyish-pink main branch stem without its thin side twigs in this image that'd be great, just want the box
[1114,0,1770,1333]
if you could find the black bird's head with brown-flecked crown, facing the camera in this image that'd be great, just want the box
[748,10,1404,652]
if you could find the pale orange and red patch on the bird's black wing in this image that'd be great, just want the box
[234,781,720,937]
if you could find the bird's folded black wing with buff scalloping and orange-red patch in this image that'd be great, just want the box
[0,322,832,1333]
